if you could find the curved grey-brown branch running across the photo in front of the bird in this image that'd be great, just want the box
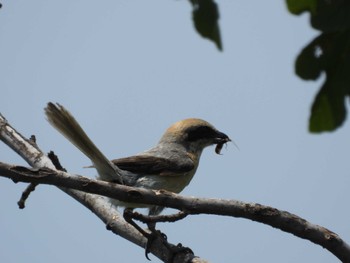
[0,163,350,262]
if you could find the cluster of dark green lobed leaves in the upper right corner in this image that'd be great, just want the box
[287,0,350,132]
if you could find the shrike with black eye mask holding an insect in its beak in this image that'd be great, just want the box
[45,103,231,215]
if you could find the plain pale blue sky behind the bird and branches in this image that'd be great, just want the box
[0,0,350,263]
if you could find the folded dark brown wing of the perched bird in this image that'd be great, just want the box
[112,155,194,175]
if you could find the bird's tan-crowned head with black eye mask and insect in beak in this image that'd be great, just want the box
[161,118,231,153]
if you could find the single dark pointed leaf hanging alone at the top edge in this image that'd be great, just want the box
[190,0,222,50]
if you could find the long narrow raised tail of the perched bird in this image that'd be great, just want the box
[45,102,123,183]
